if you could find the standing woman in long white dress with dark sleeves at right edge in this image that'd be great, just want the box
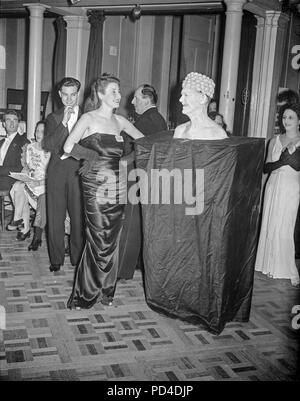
[255,103,300,286]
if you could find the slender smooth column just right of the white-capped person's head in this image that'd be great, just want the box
[219,0,246,131]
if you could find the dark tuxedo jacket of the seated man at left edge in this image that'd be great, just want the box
[0,134,29,190]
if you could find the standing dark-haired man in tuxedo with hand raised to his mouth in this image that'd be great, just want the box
[44,77,83,272]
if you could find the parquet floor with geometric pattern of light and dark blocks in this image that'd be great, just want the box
[0,227,300,382]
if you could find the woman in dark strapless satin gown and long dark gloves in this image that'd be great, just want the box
[64,74,143,309]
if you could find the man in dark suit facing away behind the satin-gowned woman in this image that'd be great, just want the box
[118,84,168,279]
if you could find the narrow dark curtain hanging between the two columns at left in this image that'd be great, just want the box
[52,17,67,109]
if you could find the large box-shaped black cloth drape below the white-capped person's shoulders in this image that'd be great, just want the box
[136,131,264,333]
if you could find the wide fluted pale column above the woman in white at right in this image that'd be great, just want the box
[249,10,289,138]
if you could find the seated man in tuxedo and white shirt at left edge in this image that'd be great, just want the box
[0,110,29,220]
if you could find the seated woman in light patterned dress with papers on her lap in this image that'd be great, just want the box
[7,121,50,251]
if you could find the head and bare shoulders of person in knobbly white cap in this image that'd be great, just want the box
[173,72,227,140]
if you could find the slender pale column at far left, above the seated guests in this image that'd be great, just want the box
[24,4,47,138]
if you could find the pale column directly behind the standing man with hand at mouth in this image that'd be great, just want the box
[64,15,90,103]
